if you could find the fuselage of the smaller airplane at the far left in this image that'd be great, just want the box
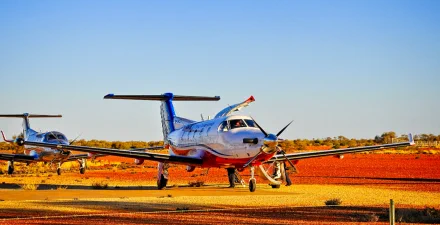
[24,129,70,162]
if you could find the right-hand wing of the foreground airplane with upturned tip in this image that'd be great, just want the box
[267,134,415,162]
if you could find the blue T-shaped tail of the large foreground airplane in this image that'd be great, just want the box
[104,93,220,144]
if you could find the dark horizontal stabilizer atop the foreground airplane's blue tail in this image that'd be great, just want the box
[104,93,220,101]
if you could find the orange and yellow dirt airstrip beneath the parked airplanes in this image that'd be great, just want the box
[0,154,440,224]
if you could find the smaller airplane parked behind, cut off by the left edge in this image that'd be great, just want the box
[0,113,90,175]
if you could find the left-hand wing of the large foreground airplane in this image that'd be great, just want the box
[18,141,202,165]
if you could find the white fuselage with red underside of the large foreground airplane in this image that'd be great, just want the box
[167,115,275,168]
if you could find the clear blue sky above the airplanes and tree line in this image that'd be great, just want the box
[0,0,440,140]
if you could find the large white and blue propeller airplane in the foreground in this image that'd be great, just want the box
[7,93,414,192]
